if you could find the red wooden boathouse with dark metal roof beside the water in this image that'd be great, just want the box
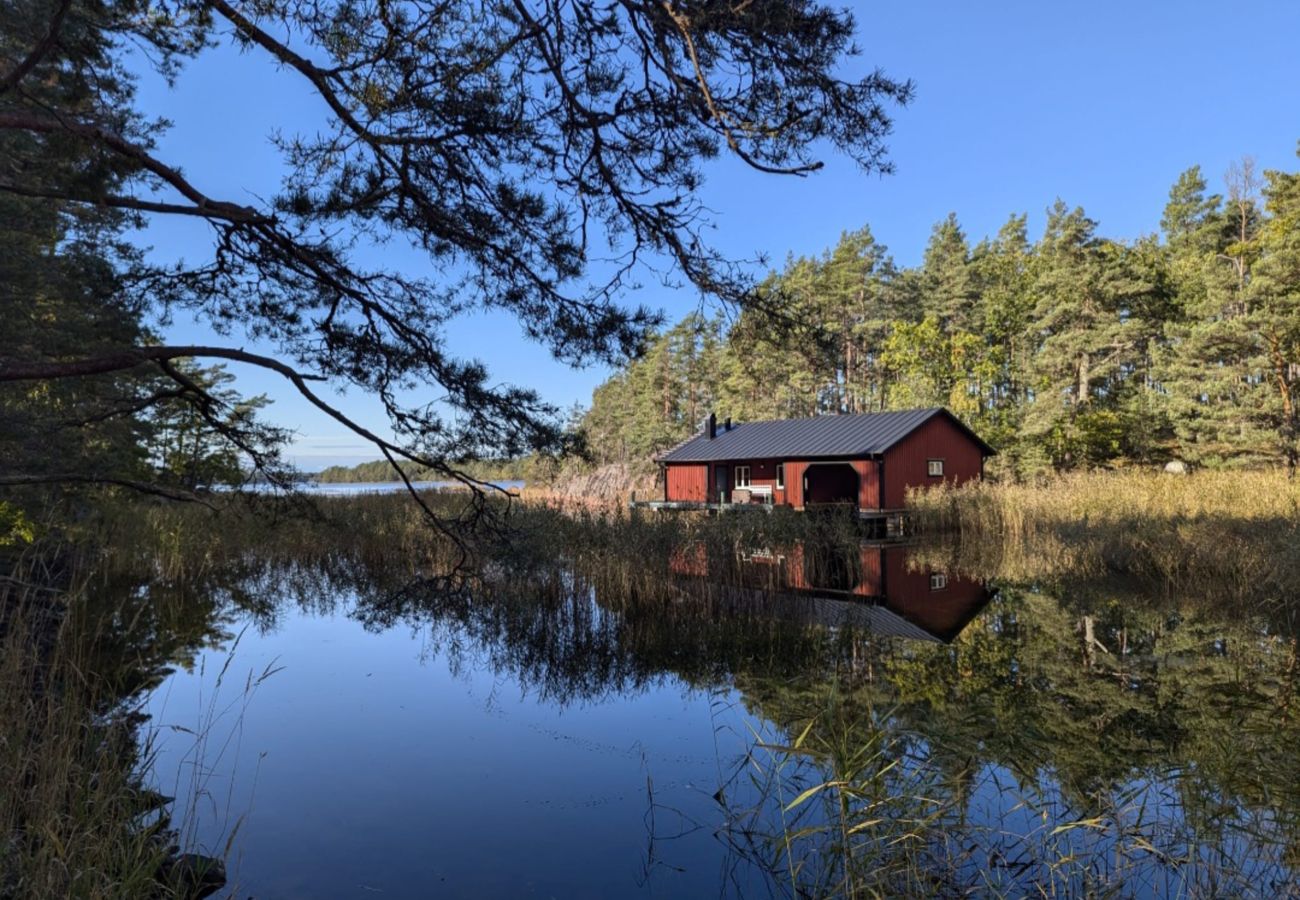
[659,407,995,511]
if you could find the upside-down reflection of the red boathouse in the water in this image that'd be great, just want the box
[671,542,989,644]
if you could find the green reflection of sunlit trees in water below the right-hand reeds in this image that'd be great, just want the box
[740,588,1300,895]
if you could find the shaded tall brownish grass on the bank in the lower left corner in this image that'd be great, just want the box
[0,569,168,897]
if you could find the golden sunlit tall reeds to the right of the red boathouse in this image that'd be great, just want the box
[909,470,1300,596]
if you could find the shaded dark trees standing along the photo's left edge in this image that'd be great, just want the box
[0,4,289,517]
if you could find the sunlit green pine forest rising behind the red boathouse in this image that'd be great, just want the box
[582,150,1300,475]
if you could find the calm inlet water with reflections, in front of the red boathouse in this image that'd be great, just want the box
[134,533,1300,897]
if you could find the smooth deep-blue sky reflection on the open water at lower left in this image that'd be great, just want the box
[150,600,759,897]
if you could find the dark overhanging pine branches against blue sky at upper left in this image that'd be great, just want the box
[0,0,911,541]
